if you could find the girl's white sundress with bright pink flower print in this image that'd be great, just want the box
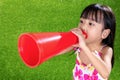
[73,49,105,80]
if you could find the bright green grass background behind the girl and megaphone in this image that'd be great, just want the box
[0,0,120,80]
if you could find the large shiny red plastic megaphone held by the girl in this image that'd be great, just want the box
[18,32,86,68]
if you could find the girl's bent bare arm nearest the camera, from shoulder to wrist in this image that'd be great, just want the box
[82,45,112,79]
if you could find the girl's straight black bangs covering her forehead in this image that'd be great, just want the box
[80,5,103,23]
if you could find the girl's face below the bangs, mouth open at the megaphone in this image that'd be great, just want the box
[78,18,104,43]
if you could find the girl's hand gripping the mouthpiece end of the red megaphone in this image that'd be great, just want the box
[71,28,86,49]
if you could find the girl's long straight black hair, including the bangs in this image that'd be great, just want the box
[80,4,116,67]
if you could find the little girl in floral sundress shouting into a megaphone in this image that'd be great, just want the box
[60,4,116,80]
